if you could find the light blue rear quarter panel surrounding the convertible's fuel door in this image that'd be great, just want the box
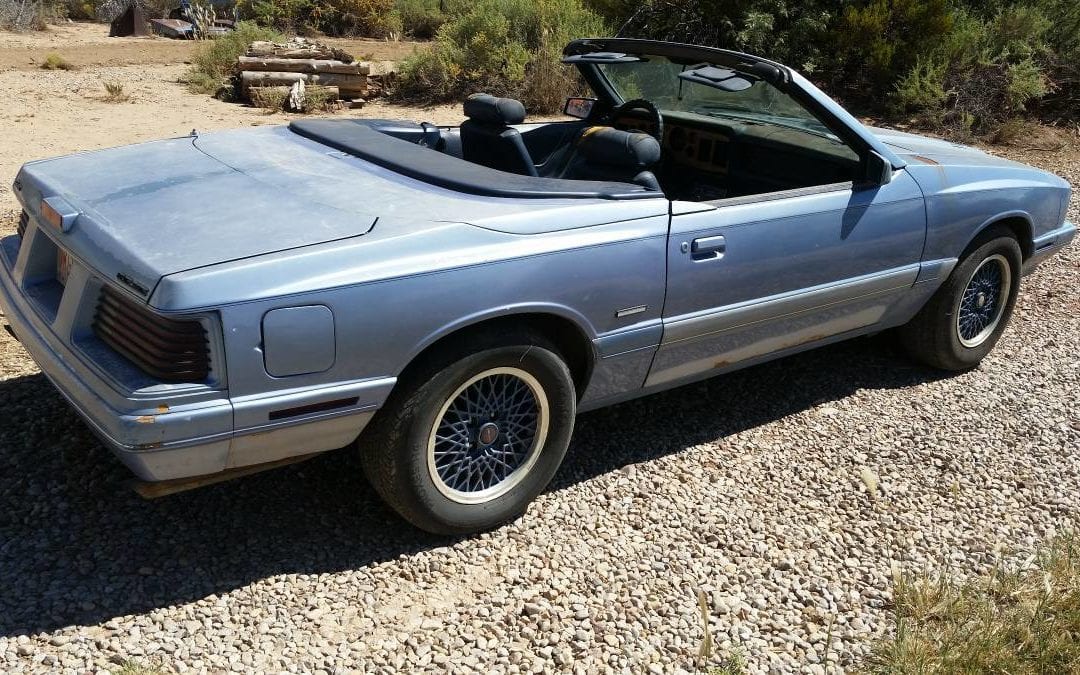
[151,205,667,416]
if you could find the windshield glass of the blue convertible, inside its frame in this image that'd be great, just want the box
[598,55,836,139]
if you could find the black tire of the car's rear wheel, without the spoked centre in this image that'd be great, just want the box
[360,330,577,535]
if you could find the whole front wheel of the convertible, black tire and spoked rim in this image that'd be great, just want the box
[900,228,1023,370]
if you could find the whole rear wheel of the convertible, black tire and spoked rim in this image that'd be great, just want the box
[362,333,577,534]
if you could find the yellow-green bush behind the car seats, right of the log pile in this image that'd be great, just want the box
[399,0,605,112]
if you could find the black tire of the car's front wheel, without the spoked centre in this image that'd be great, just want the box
[900,227,1023,370]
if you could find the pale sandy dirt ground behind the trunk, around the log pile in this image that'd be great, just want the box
[0,24,462,212]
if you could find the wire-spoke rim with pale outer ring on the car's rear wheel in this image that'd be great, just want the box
[428,367,551,504]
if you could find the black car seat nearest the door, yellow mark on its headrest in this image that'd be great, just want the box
[559,126,662,192]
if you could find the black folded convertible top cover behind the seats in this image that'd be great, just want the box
[288,120,663,200]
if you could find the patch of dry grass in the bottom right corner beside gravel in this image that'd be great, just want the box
[868,536,1080,675]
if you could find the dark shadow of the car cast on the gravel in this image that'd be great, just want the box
[0,339,937,636]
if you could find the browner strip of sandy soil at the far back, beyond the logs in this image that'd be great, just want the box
[0,23,423,70]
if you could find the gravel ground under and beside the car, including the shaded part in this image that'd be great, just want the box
[0,132,1080,673]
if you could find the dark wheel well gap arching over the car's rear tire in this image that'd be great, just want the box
[399,313,595,399]
